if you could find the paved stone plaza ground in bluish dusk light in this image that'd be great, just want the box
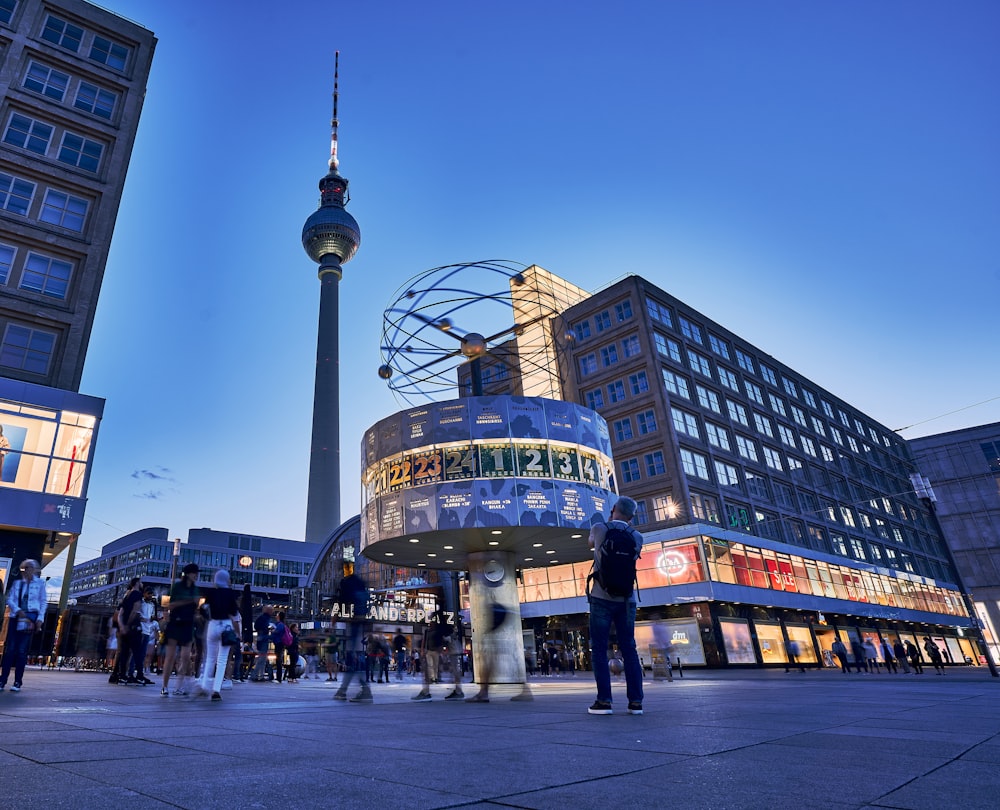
[0,668,1000,810]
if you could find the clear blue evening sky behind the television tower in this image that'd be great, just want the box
[58,0,1000,561]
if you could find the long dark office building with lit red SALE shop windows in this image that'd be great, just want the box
[512,276,981,666]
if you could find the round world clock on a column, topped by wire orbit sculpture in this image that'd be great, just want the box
[361,261,617,683]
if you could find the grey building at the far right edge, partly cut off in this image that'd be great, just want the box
[910,422,1000,661]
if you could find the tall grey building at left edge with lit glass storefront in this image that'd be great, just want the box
[0,0,156,592]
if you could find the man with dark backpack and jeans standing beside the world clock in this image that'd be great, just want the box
[587,497,643,714]
